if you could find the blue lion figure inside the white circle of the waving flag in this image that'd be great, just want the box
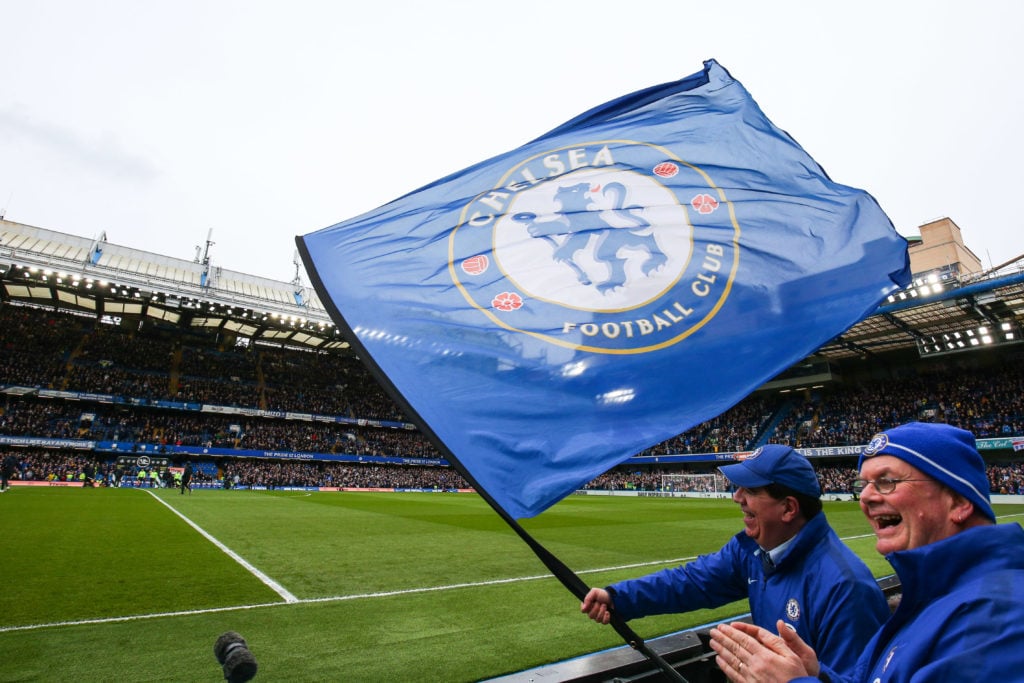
[512,182,669,293]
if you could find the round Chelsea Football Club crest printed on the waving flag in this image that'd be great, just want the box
[449,140,739,353]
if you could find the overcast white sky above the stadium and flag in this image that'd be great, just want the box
[0,0,1024,281]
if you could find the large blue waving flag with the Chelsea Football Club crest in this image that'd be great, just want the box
[297,60,909,518]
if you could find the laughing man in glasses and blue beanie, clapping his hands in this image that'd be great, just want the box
[712,423,1024,683]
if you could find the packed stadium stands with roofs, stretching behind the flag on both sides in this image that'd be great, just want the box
[0,214,1024,495]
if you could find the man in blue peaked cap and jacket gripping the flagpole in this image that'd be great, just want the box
[581,444,889,671]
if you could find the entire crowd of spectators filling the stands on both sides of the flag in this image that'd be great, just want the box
[0,305,1024,492]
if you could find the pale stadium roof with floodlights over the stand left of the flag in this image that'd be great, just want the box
[0,219,348,349]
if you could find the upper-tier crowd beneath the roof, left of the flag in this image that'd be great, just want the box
[0,305,408,422]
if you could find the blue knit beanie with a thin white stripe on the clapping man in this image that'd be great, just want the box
[857,422,995,521]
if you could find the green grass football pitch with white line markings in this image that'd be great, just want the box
[0,487,1013,682]
